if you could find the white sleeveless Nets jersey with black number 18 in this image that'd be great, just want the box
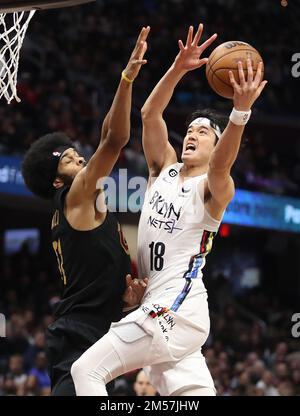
[138,163,220,312]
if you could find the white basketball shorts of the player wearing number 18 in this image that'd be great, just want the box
[110,293,214,395]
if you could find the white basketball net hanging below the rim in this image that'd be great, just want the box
[0,10,35,104]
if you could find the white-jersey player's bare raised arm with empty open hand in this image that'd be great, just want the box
[142,24,217,176]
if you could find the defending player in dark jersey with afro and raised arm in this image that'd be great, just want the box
[22,27,150,396]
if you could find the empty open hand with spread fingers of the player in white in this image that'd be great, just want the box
[175,23,217,72]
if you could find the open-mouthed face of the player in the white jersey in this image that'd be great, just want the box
[181,125,216,166]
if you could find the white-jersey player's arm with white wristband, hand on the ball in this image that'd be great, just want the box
[208,59,267,218]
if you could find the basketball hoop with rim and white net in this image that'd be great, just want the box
[0,0,95,104]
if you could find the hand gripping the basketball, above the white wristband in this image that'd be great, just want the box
[229,58,268,111]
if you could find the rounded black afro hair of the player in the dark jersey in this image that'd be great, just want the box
[22,132,74,199]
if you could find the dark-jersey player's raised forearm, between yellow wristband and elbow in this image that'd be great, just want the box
[102,79,132,149]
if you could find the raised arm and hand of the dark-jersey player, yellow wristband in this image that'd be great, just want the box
[84,27,150,194]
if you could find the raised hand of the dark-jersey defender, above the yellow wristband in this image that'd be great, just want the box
[124,26,150,81]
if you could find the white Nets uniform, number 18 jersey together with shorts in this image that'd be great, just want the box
[108,163,220,395]
